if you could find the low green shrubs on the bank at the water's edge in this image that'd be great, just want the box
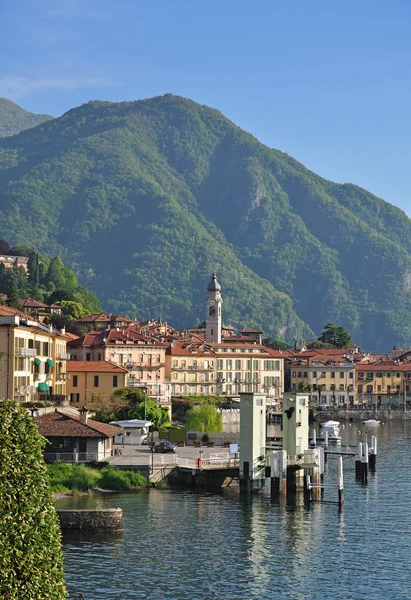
[48,462,148,492]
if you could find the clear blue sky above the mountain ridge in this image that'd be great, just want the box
[0,0,411,215]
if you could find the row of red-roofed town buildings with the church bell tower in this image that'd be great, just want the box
[0,268,411,417]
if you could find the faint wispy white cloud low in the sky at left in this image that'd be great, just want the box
[0,74,113,100]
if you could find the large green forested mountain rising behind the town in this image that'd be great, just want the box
[0,95,411,351]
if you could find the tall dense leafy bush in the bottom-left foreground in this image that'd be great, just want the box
[0,399,67,600]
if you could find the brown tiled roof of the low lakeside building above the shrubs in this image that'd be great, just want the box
[35,411,122,438]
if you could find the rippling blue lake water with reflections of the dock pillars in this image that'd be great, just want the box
[59,422,411,600]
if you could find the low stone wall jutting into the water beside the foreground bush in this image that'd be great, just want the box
[57,508,123,531]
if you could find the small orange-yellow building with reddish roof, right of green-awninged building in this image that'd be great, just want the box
[67,360,128,408]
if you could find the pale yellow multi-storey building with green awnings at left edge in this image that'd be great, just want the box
[0,306,68,402]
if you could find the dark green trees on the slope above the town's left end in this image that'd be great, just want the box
[0,240,101,320]
